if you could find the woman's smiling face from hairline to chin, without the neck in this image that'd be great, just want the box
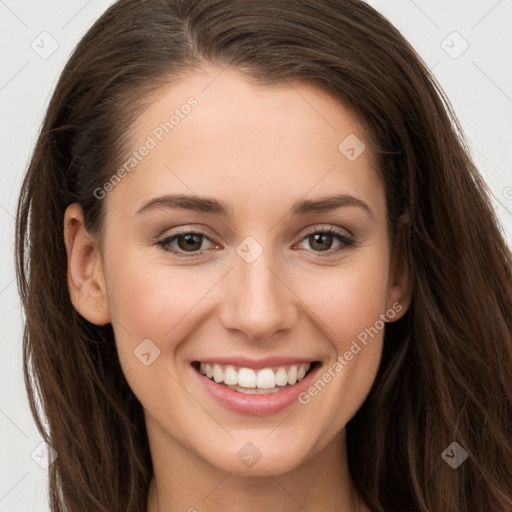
[67,68,407,475]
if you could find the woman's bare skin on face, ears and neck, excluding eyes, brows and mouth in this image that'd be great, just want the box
[64,67,410,512]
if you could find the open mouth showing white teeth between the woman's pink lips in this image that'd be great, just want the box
[192,361,320,395]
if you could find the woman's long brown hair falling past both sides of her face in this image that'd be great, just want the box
[17,0,512,512]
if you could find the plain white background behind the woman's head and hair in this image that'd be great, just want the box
[0,0,512,512]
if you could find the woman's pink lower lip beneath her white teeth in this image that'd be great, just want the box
[192,366,320,416]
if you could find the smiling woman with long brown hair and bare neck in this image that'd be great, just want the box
[17,0,512,512]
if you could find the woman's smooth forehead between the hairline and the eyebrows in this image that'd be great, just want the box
[105,68,383,220]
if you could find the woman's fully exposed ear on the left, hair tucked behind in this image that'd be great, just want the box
[64,203,110,325]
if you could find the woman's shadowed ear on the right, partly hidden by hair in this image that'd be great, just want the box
[386,213,412,322]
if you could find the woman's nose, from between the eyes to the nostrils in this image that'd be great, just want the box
[221,246,298,341]
